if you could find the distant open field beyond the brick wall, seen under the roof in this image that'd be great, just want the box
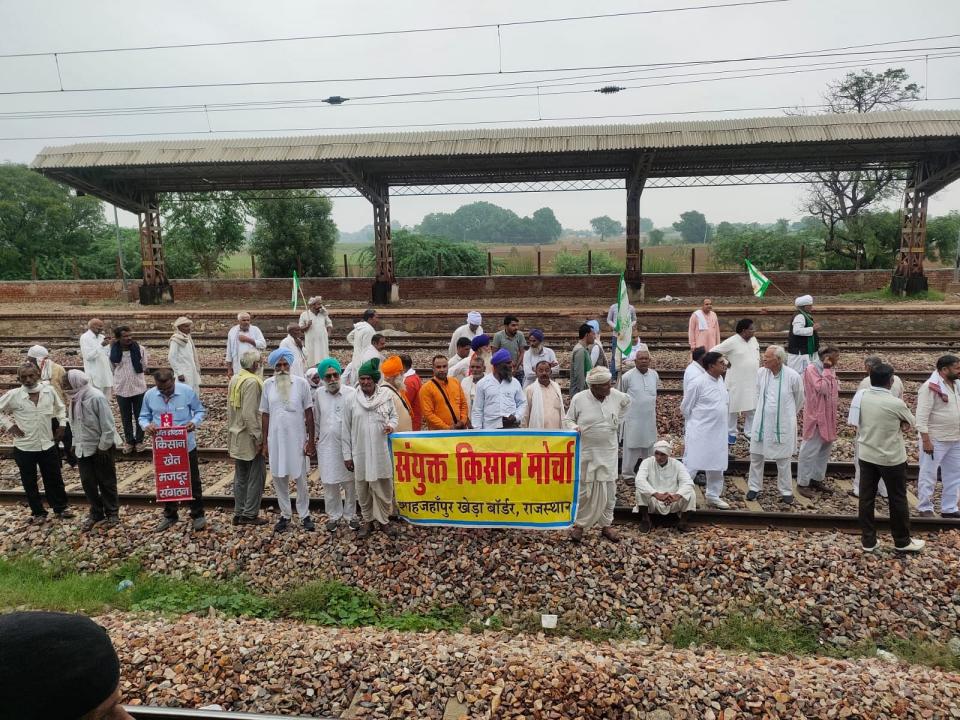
[224,238,724,278]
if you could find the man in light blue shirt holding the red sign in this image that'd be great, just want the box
[139,368,207,532]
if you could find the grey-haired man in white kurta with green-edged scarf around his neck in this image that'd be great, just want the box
[746,345,803,505]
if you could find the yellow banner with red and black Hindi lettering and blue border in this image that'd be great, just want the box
[390,430,580,529]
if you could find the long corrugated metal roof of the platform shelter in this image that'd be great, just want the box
[32,110,960,170]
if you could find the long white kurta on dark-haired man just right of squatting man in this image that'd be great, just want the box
[680,372,730,472]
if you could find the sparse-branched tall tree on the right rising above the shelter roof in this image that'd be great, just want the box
[804,68,921,269]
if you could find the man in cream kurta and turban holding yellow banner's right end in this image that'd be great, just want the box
[565,367,630,543]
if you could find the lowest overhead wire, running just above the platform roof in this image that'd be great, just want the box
[0,95,960,141]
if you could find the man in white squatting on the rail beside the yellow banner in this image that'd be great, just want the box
[636,440,697,532]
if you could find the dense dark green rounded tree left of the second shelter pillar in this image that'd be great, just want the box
[247,190,337,277]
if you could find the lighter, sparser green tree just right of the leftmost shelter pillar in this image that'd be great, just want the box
[160,192,246,277]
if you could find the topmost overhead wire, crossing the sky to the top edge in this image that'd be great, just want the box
[0,0,791,59]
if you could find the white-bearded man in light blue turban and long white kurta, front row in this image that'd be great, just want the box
[260,348,316,532]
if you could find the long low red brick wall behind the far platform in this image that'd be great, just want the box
[0,269,953,304]
